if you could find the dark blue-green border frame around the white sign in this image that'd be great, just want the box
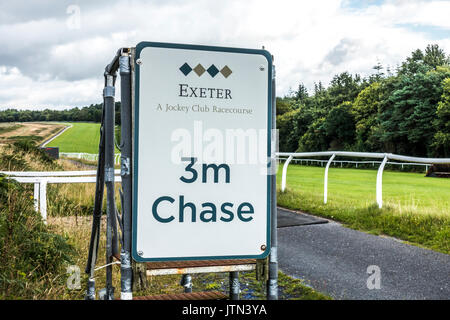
[131,41,276,262]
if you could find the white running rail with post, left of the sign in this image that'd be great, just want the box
[0,169,122,223]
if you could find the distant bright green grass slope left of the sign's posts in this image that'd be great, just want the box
[47,123,100,153]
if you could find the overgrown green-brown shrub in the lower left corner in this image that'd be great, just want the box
[0,177,75,298]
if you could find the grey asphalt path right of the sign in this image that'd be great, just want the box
[278,209,450,300]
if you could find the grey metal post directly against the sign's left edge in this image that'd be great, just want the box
[119,54,133,300]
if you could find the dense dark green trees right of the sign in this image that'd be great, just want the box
[277,45,450,157]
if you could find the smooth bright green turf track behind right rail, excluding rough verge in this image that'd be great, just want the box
[277,165,450,216]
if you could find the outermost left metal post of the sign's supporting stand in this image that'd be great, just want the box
[103,73,119,300]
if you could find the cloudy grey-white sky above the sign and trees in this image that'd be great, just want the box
[0,0,450,110]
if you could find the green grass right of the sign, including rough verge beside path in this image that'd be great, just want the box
[277,165,450,253]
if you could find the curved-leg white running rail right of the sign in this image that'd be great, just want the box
[276,151,450,208]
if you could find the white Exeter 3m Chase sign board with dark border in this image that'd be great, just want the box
[133,42,273,262]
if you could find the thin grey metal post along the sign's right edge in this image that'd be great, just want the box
[267,66,278,300]
